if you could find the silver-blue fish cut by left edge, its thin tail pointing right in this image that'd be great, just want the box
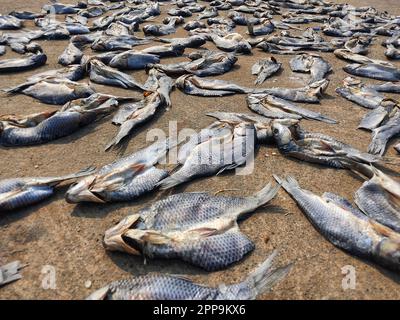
[0,167,94,211]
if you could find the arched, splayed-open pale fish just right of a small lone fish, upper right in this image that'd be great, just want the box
[290,54,332,83]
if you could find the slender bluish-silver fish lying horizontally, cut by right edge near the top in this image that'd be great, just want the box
[343,63,400,81]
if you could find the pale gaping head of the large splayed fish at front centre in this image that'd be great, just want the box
[103,214,141,255]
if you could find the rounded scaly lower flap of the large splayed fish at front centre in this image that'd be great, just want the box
[179,230,255,271]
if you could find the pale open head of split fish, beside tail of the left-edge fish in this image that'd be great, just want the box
[65,175,105,203]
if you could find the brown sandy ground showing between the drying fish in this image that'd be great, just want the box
[0,0,400,299]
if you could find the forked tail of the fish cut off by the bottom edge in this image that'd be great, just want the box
[244,250,293,299]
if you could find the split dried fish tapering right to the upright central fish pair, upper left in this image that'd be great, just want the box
[89,59,145,90]
